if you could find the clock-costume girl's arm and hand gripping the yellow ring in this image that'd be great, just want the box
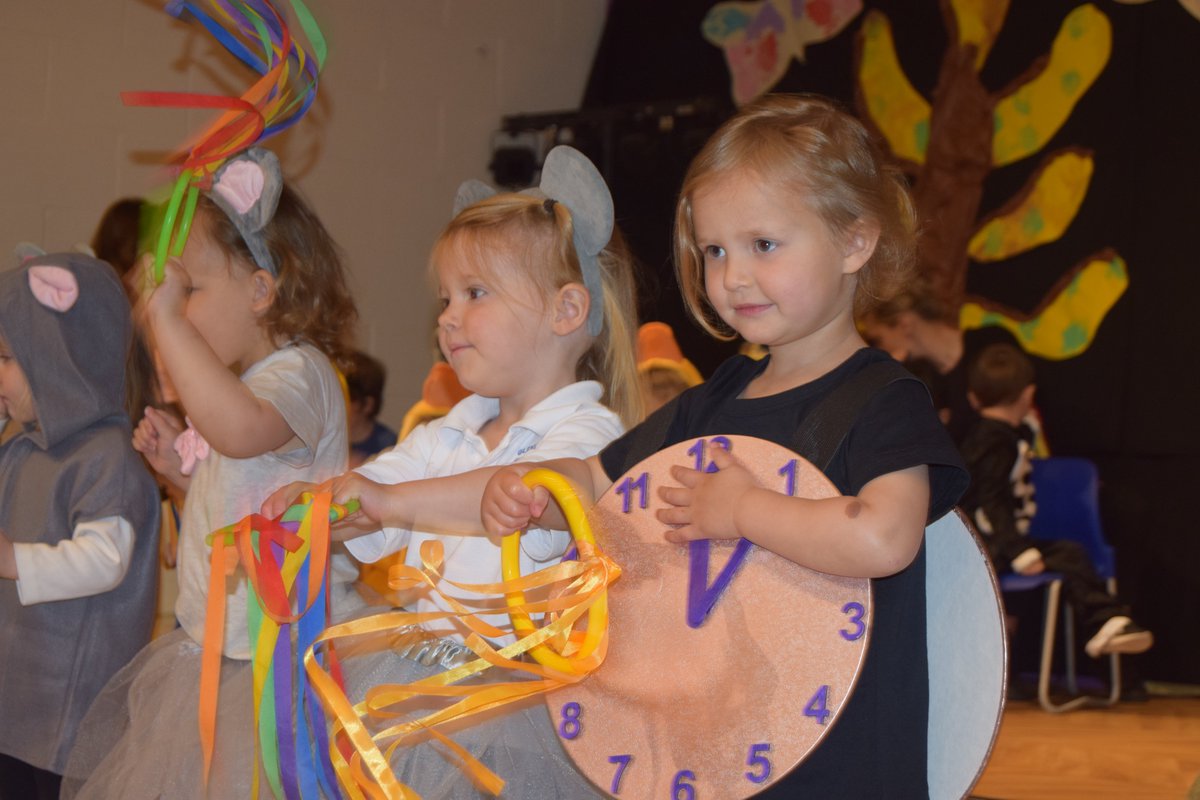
[480,456,612,536]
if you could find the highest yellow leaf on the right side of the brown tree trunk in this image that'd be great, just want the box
[991,4,1112,167]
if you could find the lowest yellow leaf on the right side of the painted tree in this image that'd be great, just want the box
[959,251,1129,360]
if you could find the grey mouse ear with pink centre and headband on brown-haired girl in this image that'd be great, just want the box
[208,148,283,276]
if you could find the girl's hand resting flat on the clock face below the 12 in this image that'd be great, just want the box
[658,447,758,543]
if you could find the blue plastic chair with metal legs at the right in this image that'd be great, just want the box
[1000,456,1121,714]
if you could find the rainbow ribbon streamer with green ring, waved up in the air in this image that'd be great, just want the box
[121,0,328,284]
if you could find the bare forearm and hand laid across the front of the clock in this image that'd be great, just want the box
[659,449,929,578]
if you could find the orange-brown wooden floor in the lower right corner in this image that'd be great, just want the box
[972,697,1200,800]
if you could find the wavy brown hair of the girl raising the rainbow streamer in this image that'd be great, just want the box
[196,184,359,372]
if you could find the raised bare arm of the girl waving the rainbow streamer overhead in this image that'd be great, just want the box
[148,259,294,458]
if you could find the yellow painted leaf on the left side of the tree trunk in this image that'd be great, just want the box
[858,11,929,164]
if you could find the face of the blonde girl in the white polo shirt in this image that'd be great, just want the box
[434,241,552,399]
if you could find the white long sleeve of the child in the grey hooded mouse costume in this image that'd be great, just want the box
[0,517,133,606]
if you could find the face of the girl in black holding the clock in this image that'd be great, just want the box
[692,170,874,355]
